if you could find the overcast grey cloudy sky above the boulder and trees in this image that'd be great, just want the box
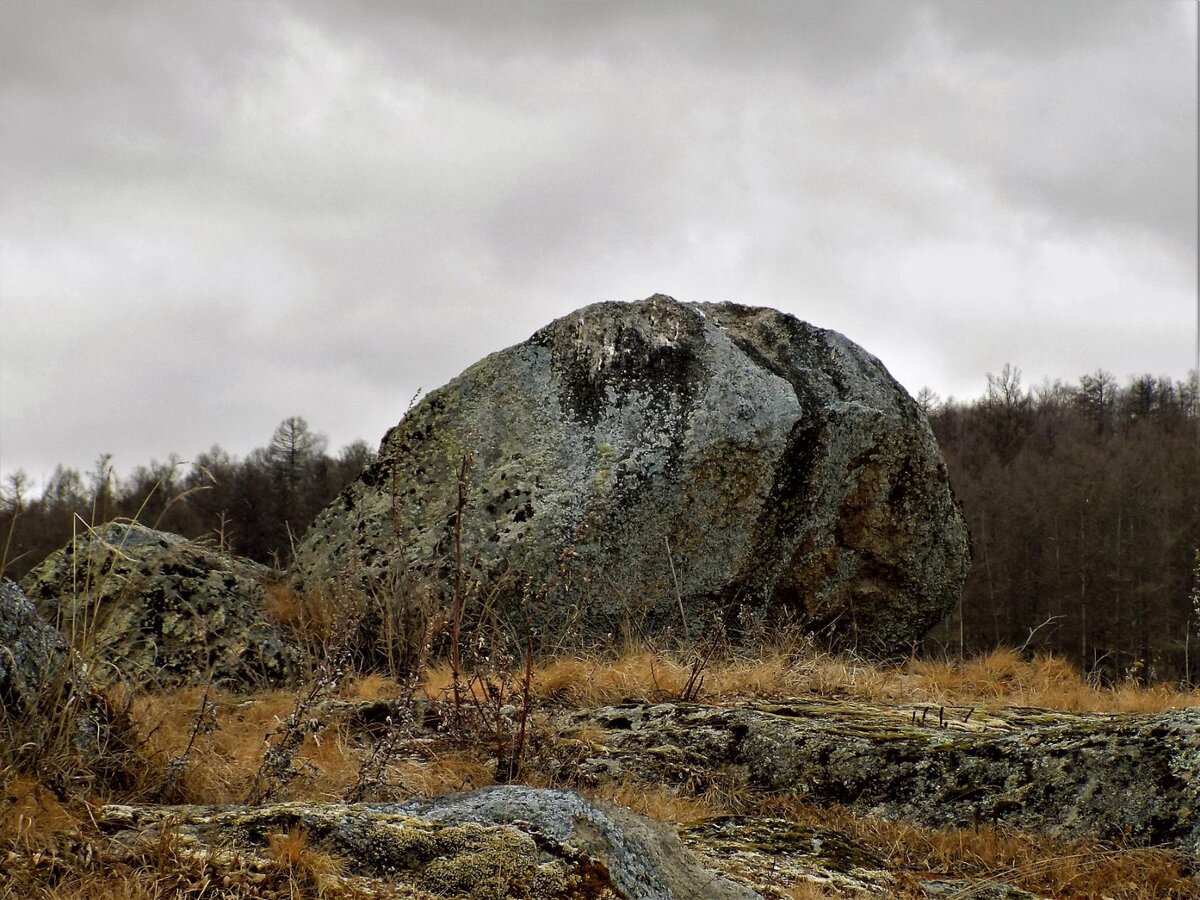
[0,0,1196,494]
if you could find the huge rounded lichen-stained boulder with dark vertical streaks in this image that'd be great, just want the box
[295,295,968,654]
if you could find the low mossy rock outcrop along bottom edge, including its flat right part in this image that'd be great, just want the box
[97,785,1051,900]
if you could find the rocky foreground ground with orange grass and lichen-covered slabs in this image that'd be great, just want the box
[0,633,1200,898]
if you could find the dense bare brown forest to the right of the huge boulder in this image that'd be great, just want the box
[918,366,1200,683]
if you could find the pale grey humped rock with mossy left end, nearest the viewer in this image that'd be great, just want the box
[98,786,758,900]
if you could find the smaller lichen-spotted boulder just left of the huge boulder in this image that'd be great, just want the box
[23,522,300,688]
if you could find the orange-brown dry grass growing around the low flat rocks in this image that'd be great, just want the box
[0,643,1200,900]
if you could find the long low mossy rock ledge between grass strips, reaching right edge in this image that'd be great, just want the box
[568,701,1200,854]
